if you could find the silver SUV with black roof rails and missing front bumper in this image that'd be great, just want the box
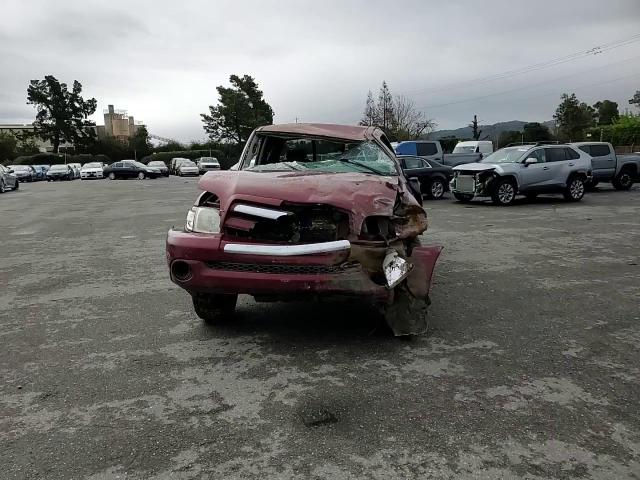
[450,144,591,205]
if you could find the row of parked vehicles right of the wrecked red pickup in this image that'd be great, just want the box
[396,142,640,205]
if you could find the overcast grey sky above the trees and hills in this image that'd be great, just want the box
[0,0,640,141]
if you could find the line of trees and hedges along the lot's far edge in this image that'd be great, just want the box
[0,75,640,165]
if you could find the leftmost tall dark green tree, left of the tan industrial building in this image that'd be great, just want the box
[27,75,97,153]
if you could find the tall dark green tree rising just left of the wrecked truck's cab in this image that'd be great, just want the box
[200,75,273,143]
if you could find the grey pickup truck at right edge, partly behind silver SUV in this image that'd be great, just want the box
[571,142,640,190]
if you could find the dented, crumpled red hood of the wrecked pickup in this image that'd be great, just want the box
[199,170,426,235]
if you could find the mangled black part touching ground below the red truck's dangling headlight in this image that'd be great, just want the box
[383,281,429,337]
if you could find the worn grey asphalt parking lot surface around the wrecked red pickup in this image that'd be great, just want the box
[0,177,640,480]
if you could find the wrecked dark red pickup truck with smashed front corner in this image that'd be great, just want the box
[167,124,441,335]
